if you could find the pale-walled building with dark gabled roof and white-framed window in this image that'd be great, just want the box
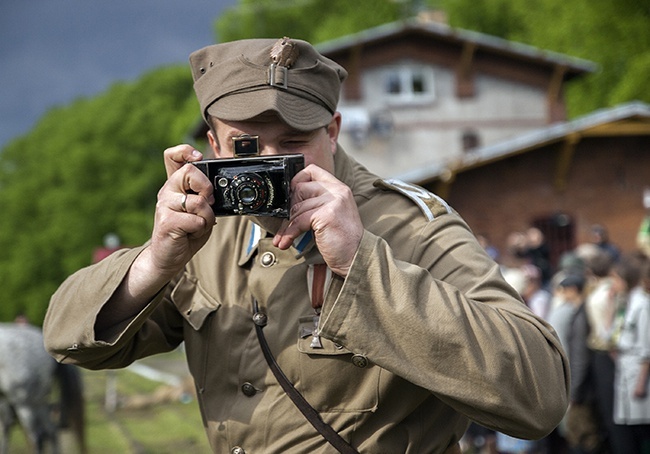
[317,19,596,177]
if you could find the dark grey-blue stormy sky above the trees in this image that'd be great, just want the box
[0,0,237,148]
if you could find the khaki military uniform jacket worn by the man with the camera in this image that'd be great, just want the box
[44,149,569,454]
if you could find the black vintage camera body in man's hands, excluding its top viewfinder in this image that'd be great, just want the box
[192,154,305,218]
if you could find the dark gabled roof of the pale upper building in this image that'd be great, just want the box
[316,19,598,80]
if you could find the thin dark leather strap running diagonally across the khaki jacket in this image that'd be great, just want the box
[253,301,359,454]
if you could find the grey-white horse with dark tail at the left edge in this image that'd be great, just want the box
[0,323,86,454]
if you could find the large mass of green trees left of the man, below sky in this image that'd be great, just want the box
[0,67,198,323]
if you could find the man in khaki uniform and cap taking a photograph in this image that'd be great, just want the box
[45,38,568,453]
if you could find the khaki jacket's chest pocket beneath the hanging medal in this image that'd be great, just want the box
[296,316,381,412]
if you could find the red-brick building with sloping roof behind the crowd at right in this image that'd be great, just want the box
[397,102,650,264]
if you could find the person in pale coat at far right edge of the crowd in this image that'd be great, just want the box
[613,256,650,454]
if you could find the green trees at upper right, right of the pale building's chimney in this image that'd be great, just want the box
[441,0,650,116]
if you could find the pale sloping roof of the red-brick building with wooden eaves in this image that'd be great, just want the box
[396,101,650,184]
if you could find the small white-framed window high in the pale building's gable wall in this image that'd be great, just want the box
[384,65,435,103]
